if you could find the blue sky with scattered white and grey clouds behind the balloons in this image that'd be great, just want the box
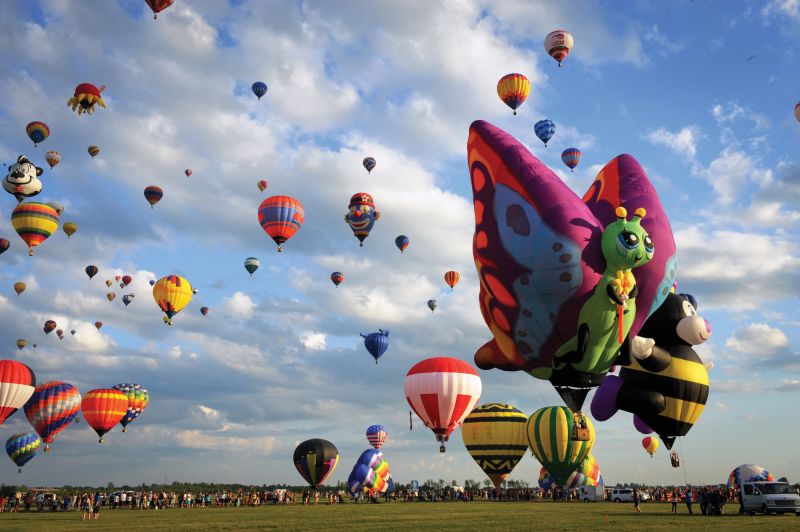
[0,0,800,486]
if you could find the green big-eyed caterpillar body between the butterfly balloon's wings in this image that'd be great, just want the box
[553,207,655,373]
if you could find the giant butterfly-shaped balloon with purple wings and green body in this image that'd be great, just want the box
[468,121,676,410]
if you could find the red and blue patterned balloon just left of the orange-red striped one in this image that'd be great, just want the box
[25,381,81,452]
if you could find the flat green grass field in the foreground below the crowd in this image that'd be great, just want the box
[0,502,800,532]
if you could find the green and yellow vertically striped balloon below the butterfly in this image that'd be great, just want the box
[526,406,594,485]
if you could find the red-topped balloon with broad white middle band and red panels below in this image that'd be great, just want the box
[403,357,481,453]
